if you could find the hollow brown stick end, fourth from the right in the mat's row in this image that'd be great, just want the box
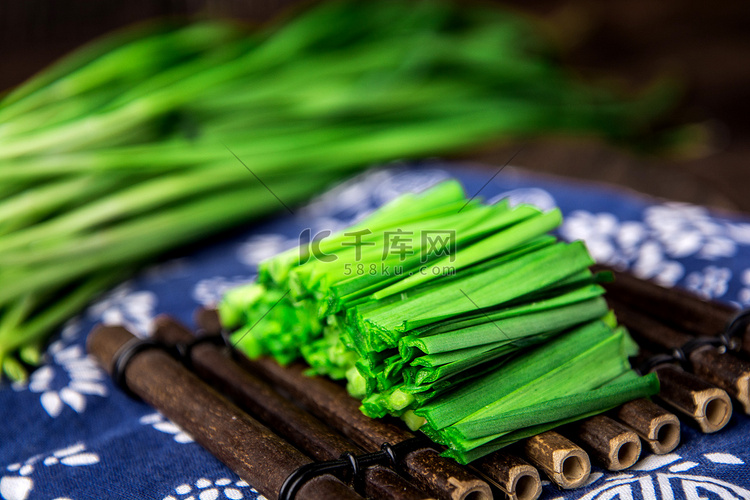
[568,415,641,471]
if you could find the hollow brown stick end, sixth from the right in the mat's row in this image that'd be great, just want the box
[471,451,542,500]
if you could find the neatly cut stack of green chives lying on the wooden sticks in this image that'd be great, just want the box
[219,181,658,463]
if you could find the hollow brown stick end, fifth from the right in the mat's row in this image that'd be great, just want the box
[523,431,591,489]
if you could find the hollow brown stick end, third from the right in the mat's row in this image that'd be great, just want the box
[612,398,680,455]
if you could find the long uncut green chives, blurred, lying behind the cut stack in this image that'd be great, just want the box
[0,1,670,379]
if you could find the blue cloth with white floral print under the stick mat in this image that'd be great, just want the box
[0,162,750,500]
